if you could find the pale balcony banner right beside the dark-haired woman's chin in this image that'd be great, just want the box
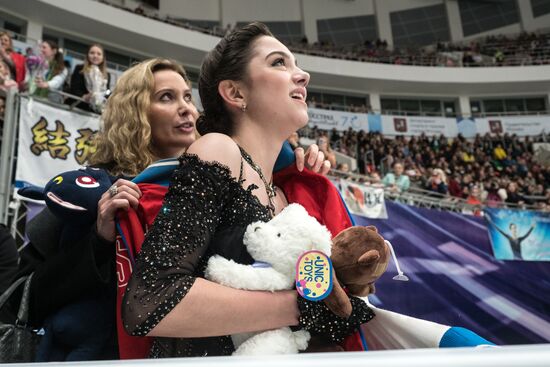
[308,108,369,132]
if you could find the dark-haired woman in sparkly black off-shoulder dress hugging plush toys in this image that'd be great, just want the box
[122,23,372,357]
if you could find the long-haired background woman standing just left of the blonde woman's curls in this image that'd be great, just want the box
[66,44,111,112]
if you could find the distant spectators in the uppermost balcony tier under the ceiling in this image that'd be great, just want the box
[98,0,550,67]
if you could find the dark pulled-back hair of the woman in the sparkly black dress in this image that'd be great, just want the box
[197,22,273,135]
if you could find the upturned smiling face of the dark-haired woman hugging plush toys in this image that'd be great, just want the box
[244,36,309,136]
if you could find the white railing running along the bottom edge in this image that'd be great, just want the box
[7,344,550,367]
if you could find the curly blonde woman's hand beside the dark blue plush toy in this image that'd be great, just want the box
[96,179,141,242]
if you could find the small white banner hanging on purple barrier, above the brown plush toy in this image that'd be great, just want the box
[340,180,388,219]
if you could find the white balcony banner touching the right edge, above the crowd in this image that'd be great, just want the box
[475,115,550,136]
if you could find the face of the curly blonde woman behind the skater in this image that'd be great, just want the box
[147,70,199,159]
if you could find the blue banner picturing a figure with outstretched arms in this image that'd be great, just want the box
[485,209,550,261]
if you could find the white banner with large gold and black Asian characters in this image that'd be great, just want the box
[15,98,99,187]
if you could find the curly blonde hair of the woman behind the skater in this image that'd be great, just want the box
[89,58,191,176]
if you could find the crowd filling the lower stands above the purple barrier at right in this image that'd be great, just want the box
[302,128,550,210]
